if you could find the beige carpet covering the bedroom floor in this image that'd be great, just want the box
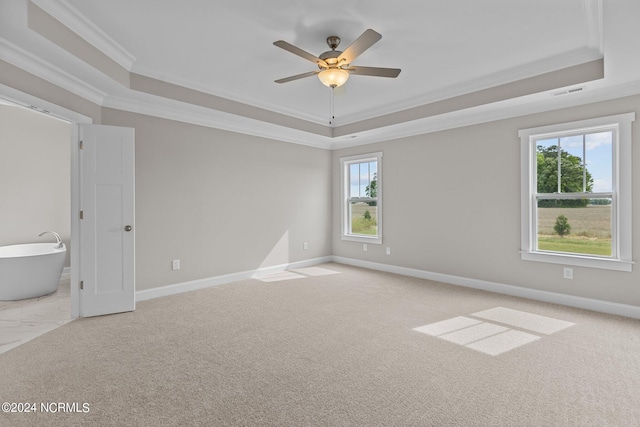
[0,264,640,426]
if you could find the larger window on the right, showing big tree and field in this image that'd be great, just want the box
[519,113,635,271]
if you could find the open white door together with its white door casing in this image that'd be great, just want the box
[0,84,135,326]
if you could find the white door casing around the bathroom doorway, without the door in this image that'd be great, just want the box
[0,84,94,319]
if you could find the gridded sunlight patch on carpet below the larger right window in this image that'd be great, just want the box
[413,307,575,356]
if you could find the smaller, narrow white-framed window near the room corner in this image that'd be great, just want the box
[340,153,382,243]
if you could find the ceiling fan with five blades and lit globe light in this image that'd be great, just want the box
[273,29,401,88]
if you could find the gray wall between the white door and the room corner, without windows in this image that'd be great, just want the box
[102,109,331,290]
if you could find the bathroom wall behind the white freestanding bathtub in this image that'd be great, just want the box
[0,105,71,266]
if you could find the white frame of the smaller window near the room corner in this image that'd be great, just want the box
[340,152,383,244]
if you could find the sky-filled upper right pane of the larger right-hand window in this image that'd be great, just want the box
[585,131,613,193]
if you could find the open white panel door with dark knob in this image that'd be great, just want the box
[79,125,135,317]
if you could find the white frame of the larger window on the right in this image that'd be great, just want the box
[518,113,635,271]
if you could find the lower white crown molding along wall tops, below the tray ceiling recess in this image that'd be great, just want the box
[6,27,640,150]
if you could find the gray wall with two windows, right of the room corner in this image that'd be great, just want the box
[332,96,640,306]
